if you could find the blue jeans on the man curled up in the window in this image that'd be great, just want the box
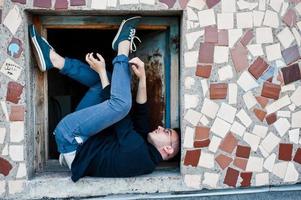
[54,55,132,153]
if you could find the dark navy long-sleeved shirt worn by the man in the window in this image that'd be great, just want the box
[71,87,162,182]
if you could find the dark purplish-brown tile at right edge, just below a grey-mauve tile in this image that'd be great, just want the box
[281,63,301,85]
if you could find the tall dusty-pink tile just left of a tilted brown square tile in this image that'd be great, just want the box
[230,42,249,72]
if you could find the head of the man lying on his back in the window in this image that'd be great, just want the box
[147,126,180,160]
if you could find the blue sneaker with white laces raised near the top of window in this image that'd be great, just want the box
[112,16,141,52]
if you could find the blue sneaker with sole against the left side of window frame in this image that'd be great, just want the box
[29,25,53,72]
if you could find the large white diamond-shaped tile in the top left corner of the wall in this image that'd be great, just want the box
[3,5,23,35]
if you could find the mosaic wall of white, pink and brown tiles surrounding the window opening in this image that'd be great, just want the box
[0,0,301,197]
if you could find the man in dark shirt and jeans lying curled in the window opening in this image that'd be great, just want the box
[30,16,179,182]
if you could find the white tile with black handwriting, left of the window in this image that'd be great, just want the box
[0,58,22,81]
